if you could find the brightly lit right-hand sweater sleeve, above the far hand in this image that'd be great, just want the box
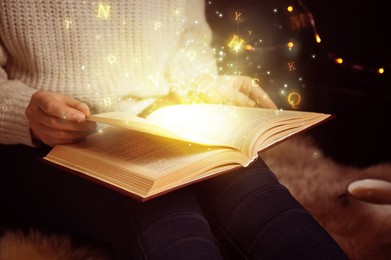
[166,0,217,103]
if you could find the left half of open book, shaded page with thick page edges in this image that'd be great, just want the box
[44,127,251,197]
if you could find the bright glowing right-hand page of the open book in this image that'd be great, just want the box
[147,104,330,157]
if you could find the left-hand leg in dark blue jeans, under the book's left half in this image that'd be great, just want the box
[0,146,224,259]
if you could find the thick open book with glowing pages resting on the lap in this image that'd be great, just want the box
[44,104,331,201]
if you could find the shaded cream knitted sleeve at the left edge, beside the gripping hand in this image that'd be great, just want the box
[0,42,36,146]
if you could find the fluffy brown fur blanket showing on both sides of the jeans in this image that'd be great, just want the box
[0,136,391,260]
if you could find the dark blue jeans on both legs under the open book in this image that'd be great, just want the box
[0,145,347,260]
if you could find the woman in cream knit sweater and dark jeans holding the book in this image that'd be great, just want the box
[0,0,346,259]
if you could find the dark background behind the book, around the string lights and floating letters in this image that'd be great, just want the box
[206,0,391,167]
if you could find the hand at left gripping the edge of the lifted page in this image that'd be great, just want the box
[25,90,96,146]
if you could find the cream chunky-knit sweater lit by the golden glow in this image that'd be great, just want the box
[0,0,216,145]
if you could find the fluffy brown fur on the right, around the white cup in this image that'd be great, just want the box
[261,136,391,260]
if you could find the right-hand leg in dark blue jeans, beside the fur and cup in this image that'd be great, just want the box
[196,157,346,259]
